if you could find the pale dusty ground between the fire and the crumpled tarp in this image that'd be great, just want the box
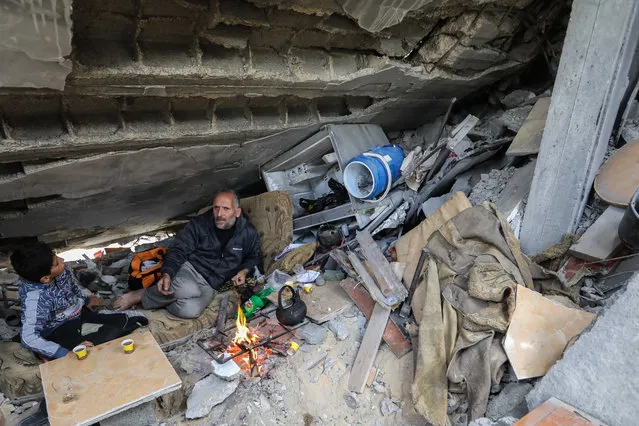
[162,308,423,426]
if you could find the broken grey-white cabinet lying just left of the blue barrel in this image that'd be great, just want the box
[262,124,398,231]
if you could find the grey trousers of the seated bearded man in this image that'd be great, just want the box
[142,262,216,318]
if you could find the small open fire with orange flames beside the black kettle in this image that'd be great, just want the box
[226,305,272,375]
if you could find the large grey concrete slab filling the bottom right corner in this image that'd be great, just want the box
[526,274,639,425]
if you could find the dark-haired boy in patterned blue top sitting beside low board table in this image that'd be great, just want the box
[11,242,148,359]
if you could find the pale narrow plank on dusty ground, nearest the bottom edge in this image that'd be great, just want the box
[348,303,390,393]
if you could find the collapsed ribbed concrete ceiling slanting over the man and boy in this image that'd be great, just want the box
[0,0,569,253]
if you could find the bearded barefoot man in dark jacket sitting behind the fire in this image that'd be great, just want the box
[114,190,262,318]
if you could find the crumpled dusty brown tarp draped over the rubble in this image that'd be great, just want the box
[412,204,533,425]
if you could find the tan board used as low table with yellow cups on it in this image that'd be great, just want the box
[40,329,182,426]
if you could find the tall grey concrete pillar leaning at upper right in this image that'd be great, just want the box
[521,0,639,254]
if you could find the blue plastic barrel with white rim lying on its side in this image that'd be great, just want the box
[344,145,404,200]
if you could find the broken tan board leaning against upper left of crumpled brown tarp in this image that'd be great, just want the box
[395,192,472,286]
